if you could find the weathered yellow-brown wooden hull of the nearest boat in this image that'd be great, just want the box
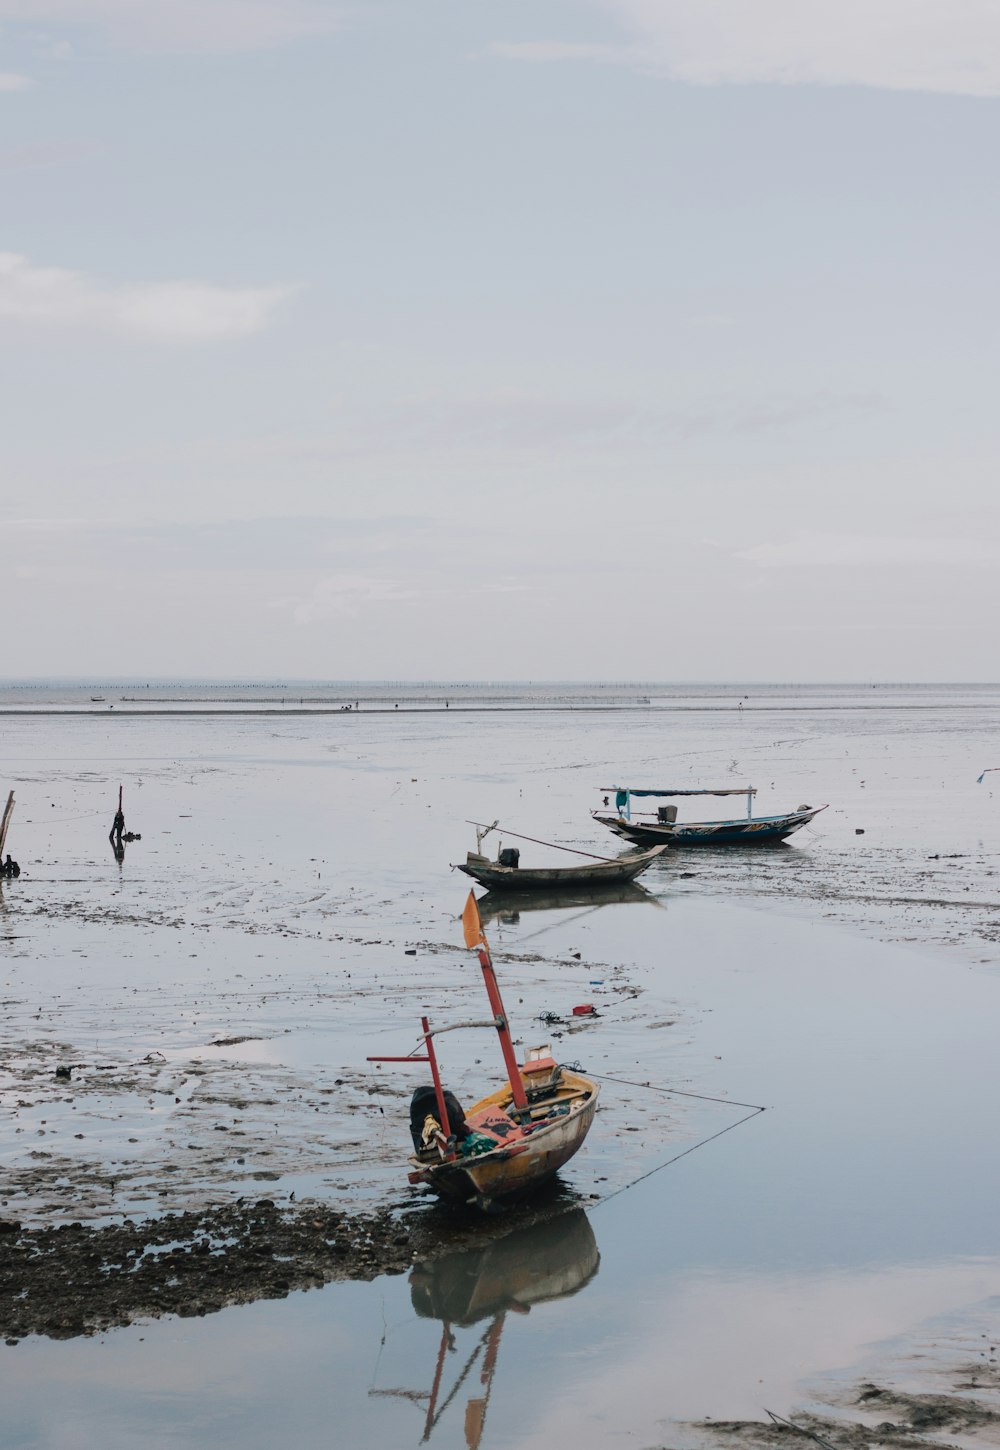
[412,1067,600,1208]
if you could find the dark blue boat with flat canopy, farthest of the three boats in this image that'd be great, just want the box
[591,786,826,847]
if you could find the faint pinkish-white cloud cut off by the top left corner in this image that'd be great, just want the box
[0,0,342,52]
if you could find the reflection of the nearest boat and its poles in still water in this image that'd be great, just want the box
[370,1208,600,1450]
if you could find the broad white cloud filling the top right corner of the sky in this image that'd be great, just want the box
[491,0,1000,96]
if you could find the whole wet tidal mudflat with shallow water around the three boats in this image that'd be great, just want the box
[0,687,1000,1450]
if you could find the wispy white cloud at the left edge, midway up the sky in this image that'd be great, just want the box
[0,252,294,342]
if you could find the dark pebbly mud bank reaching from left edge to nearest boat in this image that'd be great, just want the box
[0,1189,575,1346]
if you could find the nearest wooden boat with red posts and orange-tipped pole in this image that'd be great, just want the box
[368,892,600,1209]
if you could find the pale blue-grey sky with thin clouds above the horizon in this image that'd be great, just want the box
[0,0,1000,683]
